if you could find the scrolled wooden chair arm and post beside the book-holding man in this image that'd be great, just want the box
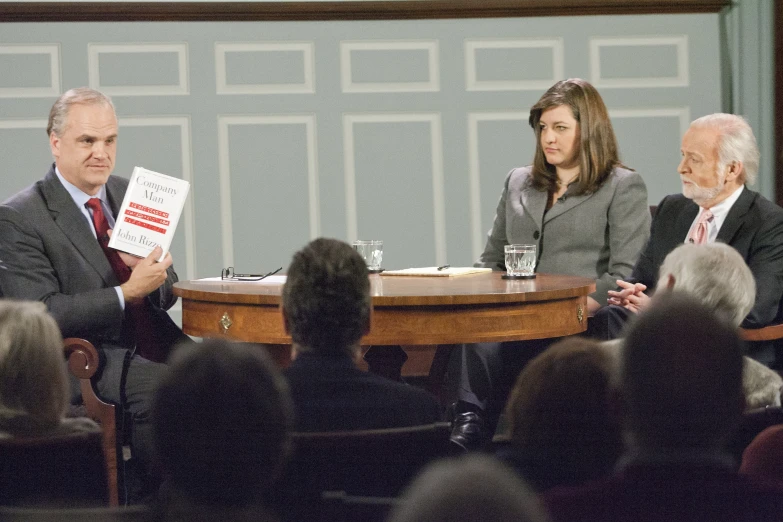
[63,337,119,506]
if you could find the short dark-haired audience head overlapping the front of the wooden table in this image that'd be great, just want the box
[282,238,372,357]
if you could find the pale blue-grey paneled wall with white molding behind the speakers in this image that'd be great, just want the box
[0,14,736,320]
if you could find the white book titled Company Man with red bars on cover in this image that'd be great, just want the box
[109,167,190,261]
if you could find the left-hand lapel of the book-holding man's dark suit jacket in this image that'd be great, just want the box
[41,167,118,286]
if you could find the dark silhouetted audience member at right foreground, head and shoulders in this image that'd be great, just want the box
[544,290,783,522]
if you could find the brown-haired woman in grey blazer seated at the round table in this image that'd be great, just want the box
[452,78,650,446]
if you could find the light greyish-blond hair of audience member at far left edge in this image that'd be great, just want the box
[0,299,70,428]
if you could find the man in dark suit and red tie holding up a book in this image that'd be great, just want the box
[0,88,186,500]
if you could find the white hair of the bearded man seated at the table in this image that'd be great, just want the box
[691,113,760,185]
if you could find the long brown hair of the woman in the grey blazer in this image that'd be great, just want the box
[528,78,620,193]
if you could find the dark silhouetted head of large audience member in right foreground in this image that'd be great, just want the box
[620,291,744,451]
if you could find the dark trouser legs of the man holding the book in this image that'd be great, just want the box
[96,348,166,503]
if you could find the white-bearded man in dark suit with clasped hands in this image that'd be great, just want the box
[591,114,783,364]
